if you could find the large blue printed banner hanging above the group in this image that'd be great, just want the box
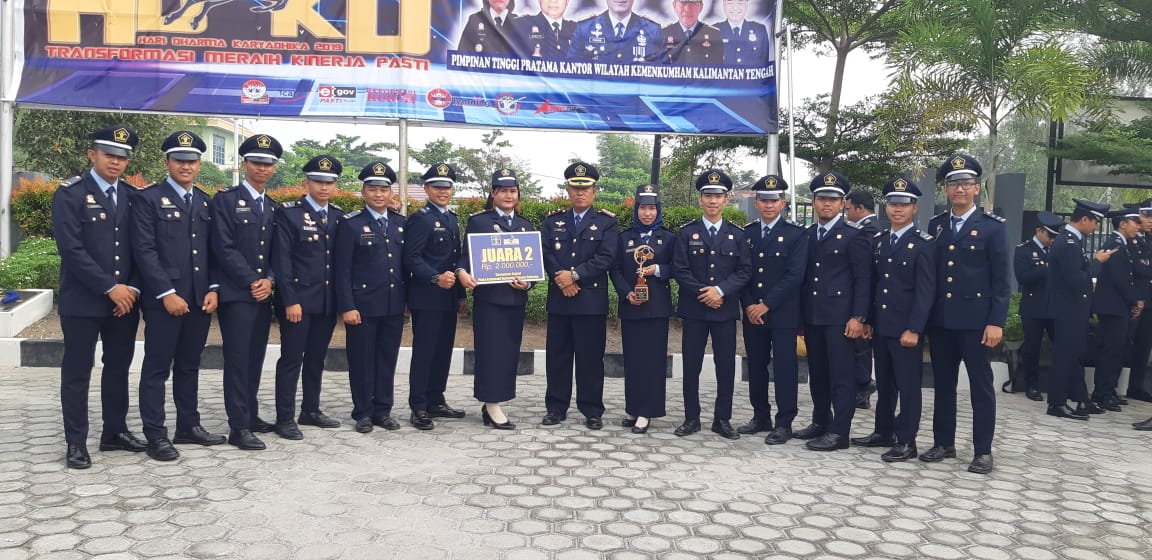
[16,0,778,135]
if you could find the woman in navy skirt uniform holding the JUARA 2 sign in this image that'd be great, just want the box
[456,168,535,430]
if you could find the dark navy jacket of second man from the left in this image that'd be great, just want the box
[131,180,212,309]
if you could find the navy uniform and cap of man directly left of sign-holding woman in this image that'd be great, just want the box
[404,164,468,430]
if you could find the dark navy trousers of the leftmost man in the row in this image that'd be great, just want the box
[60,308,141,444]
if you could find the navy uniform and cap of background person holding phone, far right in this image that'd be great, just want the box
[1091,209,1144,413]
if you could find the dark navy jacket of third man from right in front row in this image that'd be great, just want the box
[801,217,872,325]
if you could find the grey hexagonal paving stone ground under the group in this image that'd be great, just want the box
[0,369,1152,560]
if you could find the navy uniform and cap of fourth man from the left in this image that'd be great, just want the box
[272,154,344,439]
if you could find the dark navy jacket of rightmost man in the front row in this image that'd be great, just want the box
[929,209,1011,331]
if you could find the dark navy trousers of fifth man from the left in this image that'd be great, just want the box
[344,315,404,419]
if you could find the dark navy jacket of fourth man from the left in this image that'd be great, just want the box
[272,198,344,315]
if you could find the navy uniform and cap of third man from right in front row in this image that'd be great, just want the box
[795,172,872,451]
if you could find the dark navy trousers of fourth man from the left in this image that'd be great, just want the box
[276,308,336,422]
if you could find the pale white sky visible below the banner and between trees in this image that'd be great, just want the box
[242,47,887,196]
